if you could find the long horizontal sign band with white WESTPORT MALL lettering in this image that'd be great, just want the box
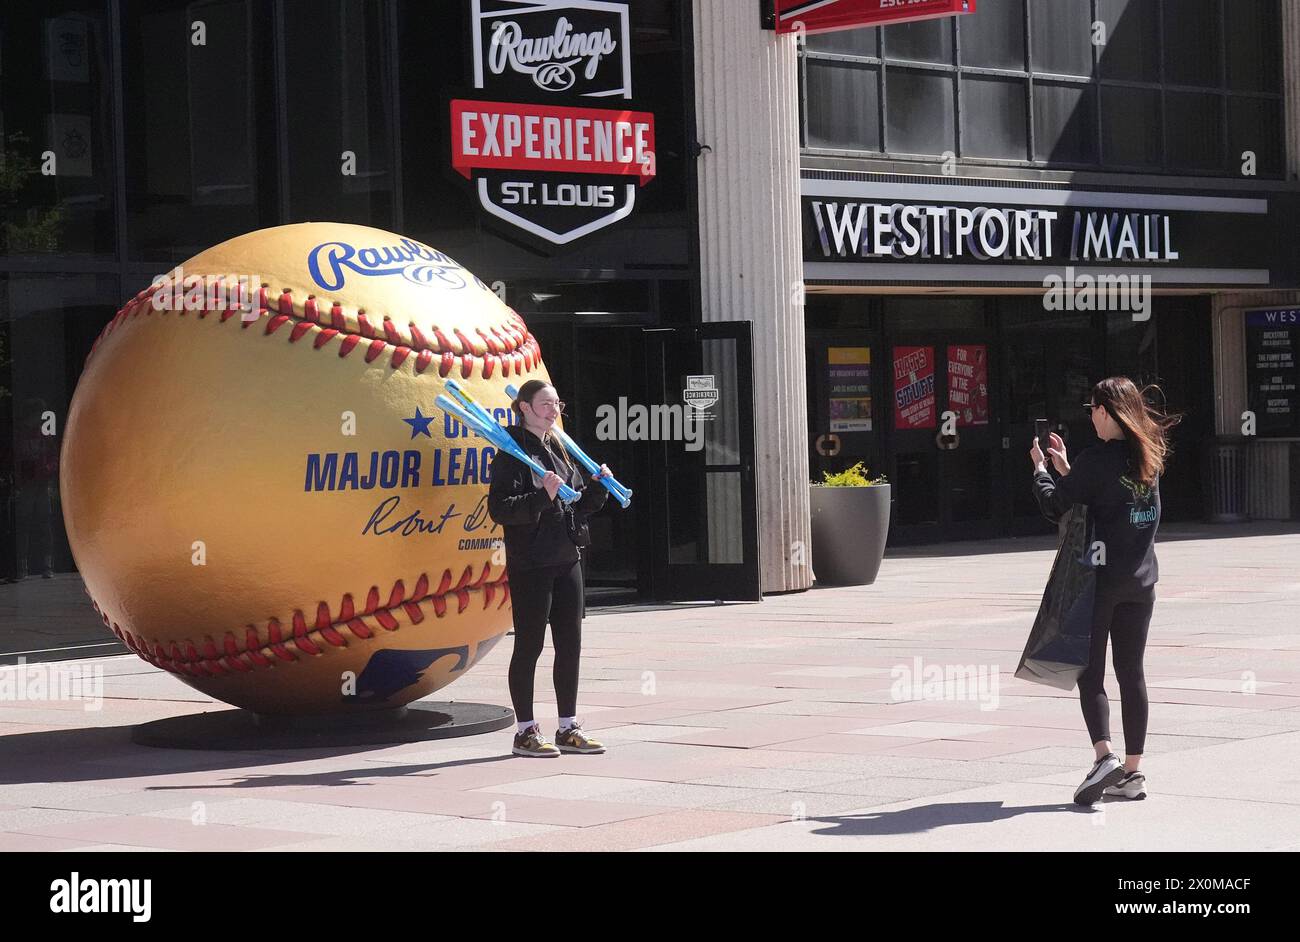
[802,175,1300,287]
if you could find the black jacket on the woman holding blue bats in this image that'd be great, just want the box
[488,425,608,573]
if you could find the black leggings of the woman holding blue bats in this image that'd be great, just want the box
[510,563,582,722]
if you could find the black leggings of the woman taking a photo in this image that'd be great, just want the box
[1079,586,1156,755]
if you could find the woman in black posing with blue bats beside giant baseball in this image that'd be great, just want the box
[488,379,610,757]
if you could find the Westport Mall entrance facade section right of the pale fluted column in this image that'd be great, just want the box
[800,0,1300,541]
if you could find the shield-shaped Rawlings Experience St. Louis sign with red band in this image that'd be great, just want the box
[450,0,655,248]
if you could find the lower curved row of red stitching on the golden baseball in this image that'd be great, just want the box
[87,563,510,677]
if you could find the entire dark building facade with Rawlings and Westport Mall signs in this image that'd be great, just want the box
[0,0,1300,662]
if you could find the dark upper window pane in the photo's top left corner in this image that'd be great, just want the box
[0,0,116,255]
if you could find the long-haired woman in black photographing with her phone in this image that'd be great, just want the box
[1030,377,1180,804]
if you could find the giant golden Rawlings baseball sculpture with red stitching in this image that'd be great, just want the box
[61,222,538,713]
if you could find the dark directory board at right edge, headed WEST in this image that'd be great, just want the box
[1245,308,1300,437]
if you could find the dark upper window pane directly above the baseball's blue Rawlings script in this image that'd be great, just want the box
[285,0,393,226]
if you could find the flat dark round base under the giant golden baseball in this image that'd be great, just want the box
[131,700,515,751]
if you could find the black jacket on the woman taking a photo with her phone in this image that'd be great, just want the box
[1034,440,1160,591]
